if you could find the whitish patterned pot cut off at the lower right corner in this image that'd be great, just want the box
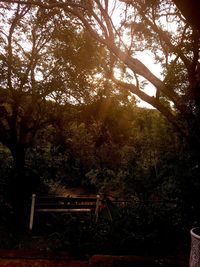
[190,227,200,267]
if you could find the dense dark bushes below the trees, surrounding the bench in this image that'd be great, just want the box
[1,96,199,254]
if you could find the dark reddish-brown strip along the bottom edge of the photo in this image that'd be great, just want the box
[0,250,189,267]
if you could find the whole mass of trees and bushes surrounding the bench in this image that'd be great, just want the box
[0,1,200,254]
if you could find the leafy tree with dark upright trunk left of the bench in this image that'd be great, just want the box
[0,4,108,216]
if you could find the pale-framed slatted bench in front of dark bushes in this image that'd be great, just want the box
[29,194,100,231]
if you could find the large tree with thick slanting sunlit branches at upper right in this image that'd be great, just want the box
[1,0,200,165]
